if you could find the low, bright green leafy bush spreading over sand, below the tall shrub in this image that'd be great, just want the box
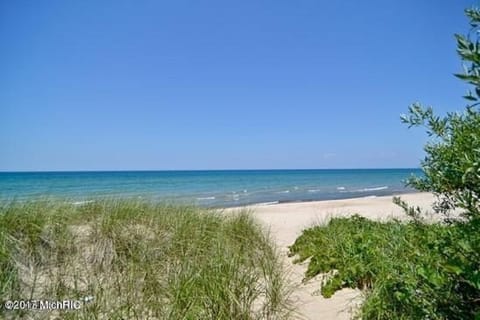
[290,215,480,319]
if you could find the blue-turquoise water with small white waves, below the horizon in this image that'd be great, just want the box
[0,169,421,207]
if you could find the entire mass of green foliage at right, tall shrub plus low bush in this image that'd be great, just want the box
[290,9,480,319]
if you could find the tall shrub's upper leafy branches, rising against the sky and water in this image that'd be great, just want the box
[401,9,480,218]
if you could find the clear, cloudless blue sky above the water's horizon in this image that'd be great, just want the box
[0,0,476,171]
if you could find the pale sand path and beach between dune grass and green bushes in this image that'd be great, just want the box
[239,193,433,320]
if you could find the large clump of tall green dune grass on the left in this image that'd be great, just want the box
[0,200,290,319]
